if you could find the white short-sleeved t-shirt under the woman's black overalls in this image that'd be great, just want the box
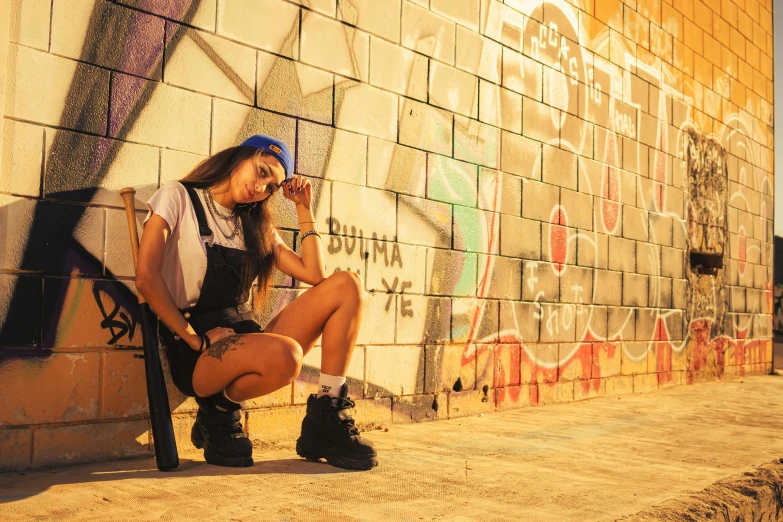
[142,181,283,309]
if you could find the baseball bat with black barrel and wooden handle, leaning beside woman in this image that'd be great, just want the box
[120,188,179,471]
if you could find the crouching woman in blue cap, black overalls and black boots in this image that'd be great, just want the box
[136,135,377,469]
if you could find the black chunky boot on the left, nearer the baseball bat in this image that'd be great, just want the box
[190,392,253,467]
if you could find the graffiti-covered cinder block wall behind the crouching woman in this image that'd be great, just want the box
[0,0,773,469]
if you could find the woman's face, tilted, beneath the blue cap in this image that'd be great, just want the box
[231,154,285,203]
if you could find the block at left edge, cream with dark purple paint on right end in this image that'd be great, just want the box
[5,44,109,134]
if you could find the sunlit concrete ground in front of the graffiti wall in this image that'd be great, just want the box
[0,376,783,522]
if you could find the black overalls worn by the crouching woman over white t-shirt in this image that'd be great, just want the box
[160,183,263,397]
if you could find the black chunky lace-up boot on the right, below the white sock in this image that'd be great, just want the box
[296,385,378,470]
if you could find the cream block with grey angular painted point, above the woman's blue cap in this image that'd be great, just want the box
[256,52,334,124]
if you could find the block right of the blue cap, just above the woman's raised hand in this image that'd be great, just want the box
[296,121,367,185]
